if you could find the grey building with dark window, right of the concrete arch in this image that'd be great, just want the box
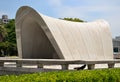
[113,36,120,59]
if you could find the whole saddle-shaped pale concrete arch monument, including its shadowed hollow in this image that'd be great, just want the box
[15,6,113,60]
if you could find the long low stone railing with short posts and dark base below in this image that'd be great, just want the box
[0,59,120,75]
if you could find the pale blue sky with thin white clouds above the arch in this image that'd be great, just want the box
[0,0,120,37]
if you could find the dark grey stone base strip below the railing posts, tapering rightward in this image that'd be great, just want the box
[0,67,59,75]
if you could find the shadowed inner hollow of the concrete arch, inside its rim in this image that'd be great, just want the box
[21,17,59,59]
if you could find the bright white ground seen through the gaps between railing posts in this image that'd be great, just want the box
[4,62,120,70]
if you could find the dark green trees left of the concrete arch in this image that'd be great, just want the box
[0,19,17,56]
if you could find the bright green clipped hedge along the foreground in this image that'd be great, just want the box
[0,68,120,82]
